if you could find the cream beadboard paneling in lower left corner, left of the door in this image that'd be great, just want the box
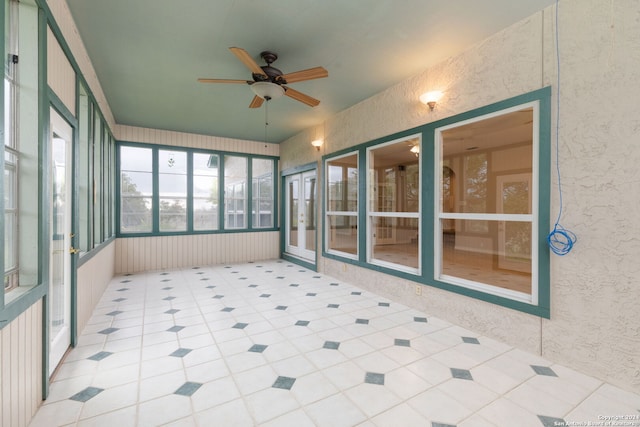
[0,300,42,427]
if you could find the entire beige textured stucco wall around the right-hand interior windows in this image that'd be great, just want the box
[280,0,640,392]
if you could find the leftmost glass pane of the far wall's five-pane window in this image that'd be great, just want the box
[120,146,153,233]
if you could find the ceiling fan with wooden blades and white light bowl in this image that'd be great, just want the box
[198,47,329,108]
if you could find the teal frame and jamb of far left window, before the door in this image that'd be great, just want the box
[0,0,48,318]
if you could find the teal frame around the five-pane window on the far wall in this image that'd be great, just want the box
[115,141,279,238]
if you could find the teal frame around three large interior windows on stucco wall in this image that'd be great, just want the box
[322,87,551,319]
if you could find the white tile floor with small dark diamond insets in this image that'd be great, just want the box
[31,260,640,427]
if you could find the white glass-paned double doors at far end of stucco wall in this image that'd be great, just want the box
[285,170,317,264]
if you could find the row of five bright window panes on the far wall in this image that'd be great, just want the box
[117,143,276,236]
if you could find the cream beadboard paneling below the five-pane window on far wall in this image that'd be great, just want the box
[115,231,280,274]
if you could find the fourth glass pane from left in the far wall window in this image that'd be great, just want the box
[224,156,247,229]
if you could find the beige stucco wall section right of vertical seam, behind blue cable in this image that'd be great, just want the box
[542,0,640,392]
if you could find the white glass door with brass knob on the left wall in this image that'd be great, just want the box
[49,109,75,374]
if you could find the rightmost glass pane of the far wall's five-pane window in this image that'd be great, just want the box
[251,159,274,228]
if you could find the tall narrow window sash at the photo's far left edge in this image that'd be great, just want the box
[4,1,20,290]
